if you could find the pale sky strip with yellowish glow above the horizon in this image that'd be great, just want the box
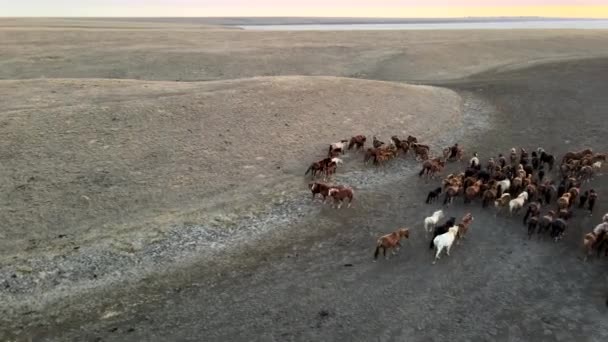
[0,0,608,18]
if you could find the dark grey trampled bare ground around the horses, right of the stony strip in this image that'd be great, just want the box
[19,60,608,341]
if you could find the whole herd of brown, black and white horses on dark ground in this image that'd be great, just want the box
[305,135,608,263]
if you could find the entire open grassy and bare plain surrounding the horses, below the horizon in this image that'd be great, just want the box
[0,19,608,341]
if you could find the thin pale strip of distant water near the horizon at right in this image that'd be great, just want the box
[238,20,608,31]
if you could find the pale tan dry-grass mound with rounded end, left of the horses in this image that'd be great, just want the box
[0,77,461,254]
